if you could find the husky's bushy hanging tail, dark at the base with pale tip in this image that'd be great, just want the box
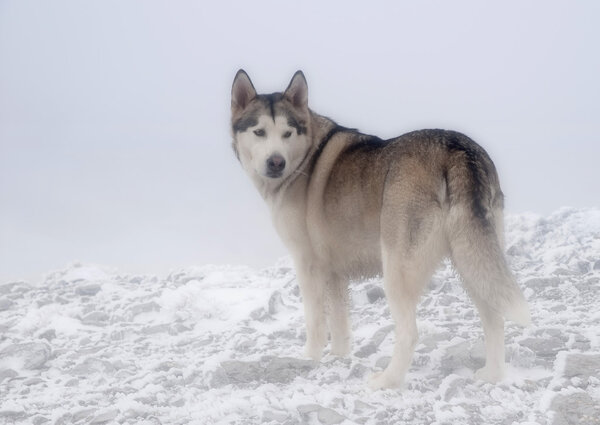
[444,132,531,326]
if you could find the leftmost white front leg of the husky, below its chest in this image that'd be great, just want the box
[296,263,327,361]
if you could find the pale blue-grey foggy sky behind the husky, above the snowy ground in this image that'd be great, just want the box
[0,0,600,282]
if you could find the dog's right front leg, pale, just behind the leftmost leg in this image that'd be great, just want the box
[327,276,352,356]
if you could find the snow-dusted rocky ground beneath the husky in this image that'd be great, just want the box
[0,209,600,425]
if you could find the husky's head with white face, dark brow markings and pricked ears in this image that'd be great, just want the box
[231,70,311,184]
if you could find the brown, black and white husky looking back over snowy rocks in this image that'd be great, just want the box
[231,70,530,389]
